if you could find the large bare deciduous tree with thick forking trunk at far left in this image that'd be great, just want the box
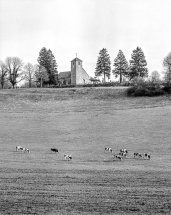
[5,57,24,88]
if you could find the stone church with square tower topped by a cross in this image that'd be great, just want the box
[58,56,91,85]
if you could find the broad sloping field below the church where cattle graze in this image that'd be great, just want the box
[0,88,171,215]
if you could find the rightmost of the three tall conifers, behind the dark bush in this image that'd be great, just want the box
[129,47,148,79]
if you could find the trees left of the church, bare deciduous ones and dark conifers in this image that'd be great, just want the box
[0,47,58,89]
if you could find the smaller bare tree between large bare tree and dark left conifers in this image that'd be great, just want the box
[23,63,37,88]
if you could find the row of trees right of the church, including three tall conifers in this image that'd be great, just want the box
[95,47,171,83]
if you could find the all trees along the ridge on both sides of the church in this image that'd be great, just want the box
[0,47,171,89]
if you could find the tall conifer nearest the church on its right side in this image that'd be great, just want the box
[95,48,111,82]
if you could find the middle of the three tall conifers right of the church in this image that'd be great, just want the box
[112,50,128,83]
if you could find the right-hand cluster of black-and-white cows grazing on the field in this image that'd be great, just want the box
[105,147,150,160]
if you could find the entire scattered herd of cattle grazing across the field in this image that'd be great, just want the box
[16,146,150,161]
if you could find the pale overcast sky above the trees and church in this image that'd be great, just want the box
[0,0,171,79]
